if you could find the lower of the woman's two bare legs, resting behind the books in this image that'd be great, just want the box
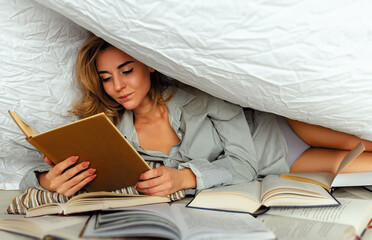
[290,148,372,173]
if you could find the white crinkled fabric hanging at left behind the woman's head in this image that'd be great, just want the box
[0,0,87,189]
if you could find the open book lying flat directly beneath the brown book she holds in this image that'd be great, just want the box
[26,192,170,217]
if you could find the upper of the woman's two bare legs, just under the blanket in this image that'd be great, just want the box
[287,119,372,151]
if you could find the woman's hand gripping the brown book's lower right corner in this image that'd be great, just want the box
[136,166,196,196]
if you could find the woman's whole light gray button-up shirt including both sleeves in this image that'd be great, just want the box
[20,87,288,193]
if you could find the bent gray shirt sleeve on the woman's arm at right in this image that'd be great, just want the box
[179,95,258,190]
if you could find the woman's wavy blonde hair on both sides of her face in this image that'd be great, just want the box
[69,34,174,125]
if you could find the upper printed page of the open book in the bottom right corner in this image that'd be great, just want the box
[267,198,372,234]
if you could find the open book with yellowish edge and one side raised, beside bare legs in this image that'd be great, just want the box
[281,142,365,191]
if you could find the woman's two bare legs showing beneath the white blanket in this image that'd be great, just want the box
[287,119,372,173]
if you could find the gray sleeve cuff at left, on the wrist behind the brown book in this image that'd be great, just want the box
[19,162,50,193]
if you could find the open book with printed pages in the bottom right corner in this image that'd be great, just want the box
[257,198,372,240]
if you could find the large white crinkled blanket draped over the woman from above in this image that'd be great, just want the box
[37,0,372,140]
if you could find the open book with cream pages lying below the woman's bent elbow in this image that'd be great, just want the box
[187,175,339,215]
